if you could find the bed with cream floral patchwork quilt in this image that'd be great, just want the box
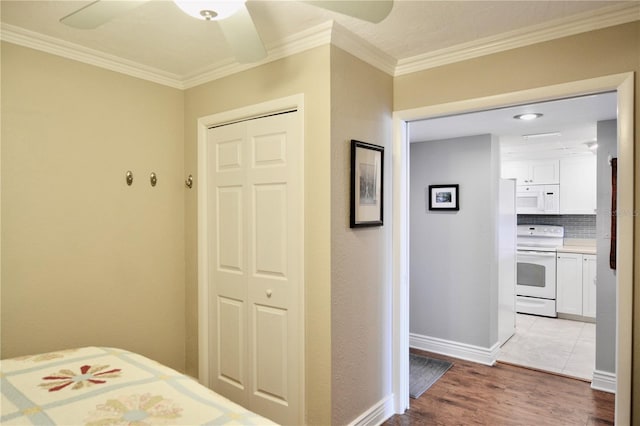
[0,347,275,426]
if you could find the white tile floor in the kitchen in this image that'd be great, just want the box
[498,314,596,381]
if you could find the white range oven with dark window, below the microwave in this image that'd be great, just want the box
[516,225,564,317]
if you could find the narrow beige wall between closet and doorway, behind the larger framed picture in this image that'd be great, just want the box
[331,47,393,425]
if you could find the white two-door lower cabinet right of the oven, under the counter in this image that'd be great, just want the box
[556,253,596,318]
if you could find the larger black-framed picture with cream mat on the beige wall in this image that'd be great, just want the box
[350,140,384,228]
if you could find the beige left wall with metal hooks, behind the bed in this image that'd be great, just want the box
[1,43,185,370]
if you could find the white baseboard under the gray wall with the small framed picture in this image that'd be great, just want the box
[409,333,500,365]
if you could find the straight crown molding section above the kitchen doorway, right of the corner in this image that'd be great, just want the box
[394,2,640,76]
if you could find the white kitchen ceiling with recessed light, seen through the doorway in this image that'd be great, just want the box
[409,92,617,160]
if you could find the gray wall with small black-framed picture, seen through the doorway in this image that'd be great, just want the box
[409,135,499,348]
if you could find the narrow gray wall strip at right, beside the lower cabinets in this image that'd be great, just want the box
[596,120,618,373]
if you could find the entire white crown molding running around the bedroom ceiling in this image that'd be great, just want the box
[0,1,640,89]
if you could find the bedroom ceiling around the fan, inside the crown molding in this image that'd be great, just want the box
[0,0,640,87]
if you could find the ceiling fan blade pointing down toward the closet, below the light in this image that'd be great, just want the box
[218,4,267,63]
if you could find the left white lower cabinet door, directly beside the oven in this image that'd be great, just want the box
[556,253,582,315]
